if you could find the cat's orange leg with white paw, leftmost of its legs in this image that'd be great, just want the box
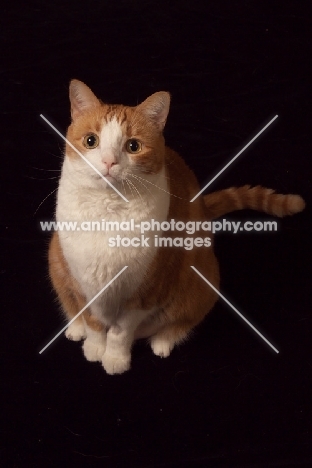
[49,232,86,341]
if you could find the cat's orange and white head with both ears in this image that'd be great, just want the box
[66,80,170,190]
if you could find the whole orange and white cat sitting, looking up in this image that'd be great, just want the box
[48,80,305,374]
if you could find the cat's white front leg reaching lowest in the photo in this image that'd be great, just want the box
[102,310,148,374]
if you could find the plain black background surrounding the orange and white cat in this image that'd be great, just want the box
[0,0,312,467]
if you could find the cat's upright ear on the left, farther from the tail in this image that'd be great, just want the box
[69,80,101,121]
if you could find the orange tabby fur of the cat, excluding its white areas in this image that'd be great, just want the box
[49,81,304,373]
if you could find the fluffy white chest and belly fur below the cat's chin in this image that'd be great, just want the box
[56,158,169,318]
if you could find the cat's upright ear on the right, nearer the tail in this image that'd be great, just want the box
[137,91,170,131]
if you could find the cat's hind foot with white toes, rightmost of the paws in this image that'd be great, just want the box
[150,322,196,358]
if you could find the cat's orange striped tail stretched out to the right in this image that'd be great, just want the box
[204,185,305,219]
